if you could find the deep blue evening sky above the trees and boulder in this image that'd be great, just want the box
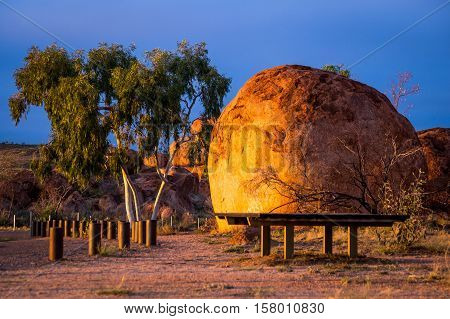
[0,0,450,143]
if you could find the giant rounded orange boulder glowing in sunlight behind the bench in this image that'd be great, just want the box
[208,65,425,230]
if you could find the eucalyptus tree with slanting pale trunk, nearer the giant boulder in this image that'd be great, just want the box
[127,41,231,219]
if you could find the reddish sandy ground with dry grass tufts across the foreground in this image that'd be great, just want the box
[0,231,449,298]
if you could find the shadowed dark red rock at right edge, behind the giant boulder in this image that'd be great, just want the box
[418,128,450,213]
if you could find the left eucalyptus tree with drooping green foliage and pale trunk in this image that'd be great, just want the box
[9,44,150,221]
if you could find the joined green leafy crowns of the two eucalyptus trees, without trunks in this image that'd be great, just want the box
[9,41,230,190]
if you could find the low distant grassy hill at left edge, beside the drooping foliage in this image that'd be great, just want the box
[0,143,39,179]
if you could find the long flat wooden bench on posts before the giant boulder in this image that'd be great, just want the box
[216,213,409,259]
